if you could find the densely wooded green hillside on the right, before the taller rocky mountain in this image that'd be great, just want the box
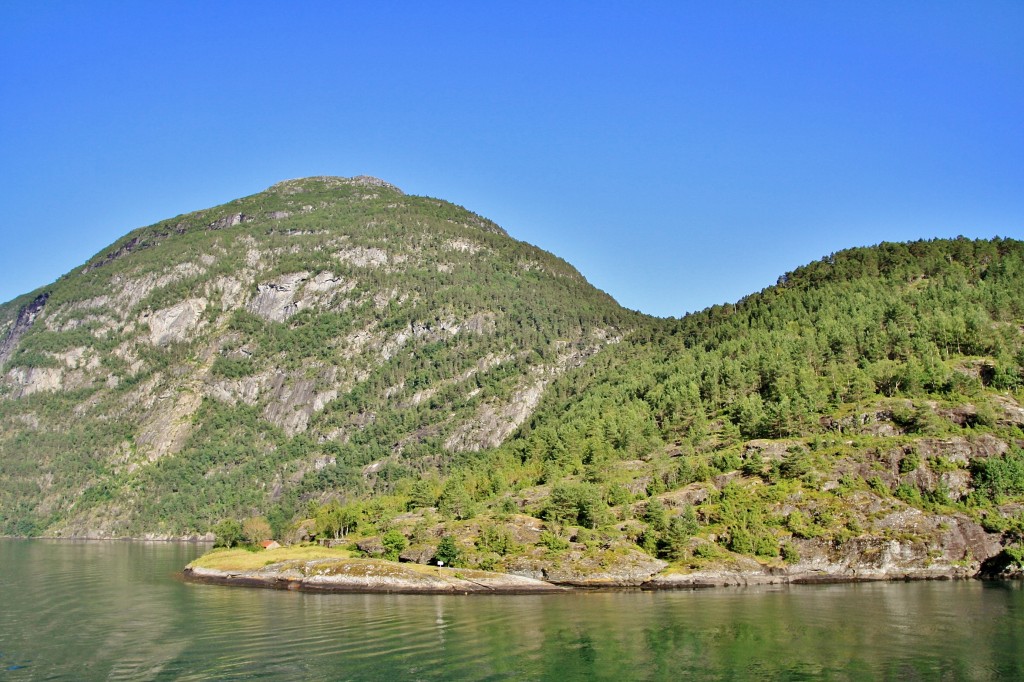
[448,235,1024,584]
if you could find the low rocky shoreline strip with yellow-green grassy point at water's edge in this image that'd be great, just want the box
[184,522,1021,594]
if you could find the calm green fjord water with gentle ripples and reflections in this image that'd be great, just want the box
[0,540,1024,680]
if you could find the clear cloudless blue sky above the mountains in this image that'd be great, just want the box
[0,0,1024,315]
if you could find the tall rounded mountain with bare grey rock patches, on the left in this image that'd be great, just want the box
[0,177,638,536]
